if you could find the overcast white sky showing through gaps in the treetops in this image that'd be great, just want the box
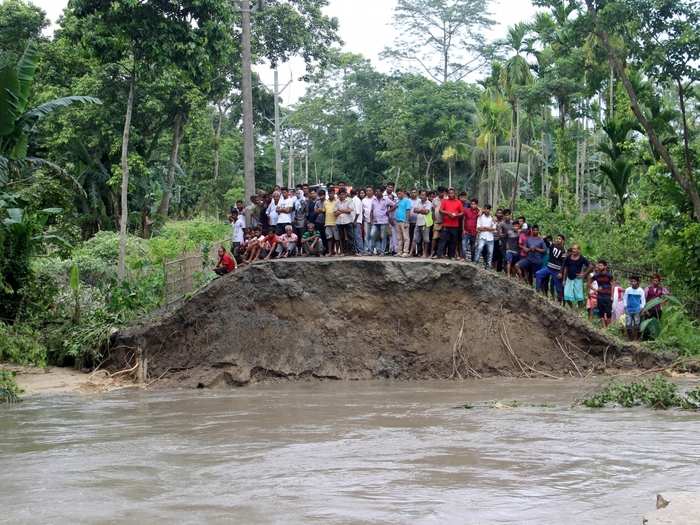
[30,0,535,102]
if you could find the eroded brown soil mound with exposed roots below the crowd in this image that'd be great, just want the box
[110,258,666,387]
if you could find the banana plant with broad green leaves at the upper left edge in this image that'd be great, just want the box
[0,42,101,184]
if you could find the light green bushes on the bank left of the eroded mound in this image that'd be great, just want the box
[0,218,230,367]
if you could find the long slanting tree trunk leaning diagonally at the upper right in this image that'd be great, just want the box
[586,0,700,221]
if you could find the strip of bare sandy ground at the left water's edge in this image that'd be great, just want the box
[0,364,133,396]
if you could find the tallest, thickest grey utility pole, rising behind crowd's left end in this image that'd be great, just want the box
[240,0,255,201]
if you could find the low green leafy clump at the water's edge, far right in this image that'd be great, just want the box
[581,375,700,410]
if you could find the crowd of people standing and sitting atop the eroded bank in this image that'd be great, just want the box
[215,182,668,339]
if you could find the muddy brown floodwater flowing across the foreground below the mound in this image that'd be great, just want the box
[0,379,700,524]
